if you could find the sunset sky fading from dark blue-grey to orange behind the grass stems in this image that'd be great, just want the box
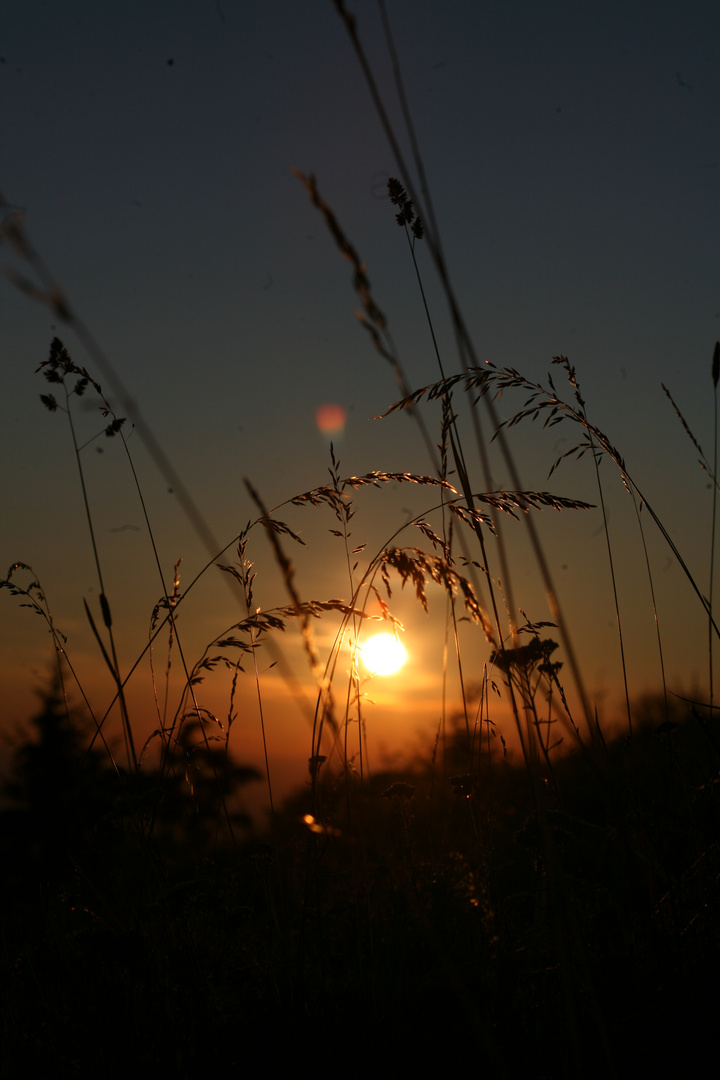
[0,0,720,812]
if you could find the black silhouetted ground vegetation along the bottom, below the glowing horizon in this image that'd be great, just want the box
[1,678,720,1077]
